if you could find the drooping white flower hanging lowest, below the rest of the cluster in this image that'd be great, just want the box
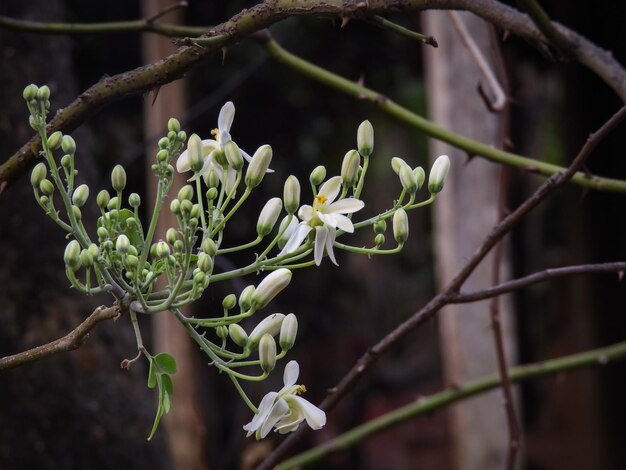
[243,361,326,440]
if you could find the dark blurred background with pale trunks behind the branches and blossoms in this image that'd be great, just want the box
[0,0,626,470]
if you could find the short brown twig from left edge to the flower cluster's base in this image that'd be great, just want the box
[0,302,122,371]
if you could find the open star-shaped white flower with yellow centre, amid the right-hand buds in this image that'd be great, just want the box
[278,176,365,266]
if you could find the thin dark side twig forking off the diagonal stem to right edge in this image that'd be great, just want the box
[448,262,626,304]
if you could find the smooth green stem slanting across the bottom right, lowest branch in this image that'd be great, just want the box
[275,342,626,470]
